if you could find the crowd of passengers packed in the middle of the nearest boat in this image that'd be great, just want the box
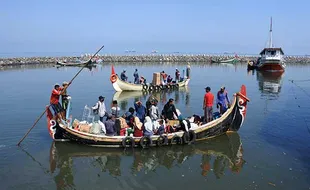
[86,93,183,137]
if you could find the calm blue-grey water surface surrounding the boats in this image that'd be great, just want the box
[0,64,310,189]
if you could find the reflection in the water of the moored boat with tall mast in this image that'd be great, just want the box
[256,71,284,99]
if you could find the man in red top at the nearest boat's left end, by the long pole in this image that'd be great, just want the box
[50,83,65,121]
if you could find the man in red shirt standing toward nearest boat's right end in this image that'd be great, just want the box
[202,86,214,123]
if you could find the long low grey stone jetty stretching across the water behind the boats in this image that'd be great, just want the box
[0,54,310,67]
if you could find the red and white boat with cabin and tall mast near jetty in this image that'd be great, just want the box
[256,18,285,72]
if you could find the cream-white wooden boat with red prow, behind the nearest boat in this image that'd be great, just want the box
[110,65,190,92]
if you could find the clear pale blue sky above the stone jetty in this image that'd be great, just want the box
[0,0,310,57]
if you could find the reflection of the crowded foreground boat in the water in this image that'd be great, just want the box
[50,133,245,188]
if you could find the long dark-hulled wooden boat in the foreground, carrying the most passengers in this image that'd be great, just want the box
[46,85,249,147]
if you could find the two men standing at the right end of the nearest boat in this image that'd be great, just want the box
[202,86,230,122]
